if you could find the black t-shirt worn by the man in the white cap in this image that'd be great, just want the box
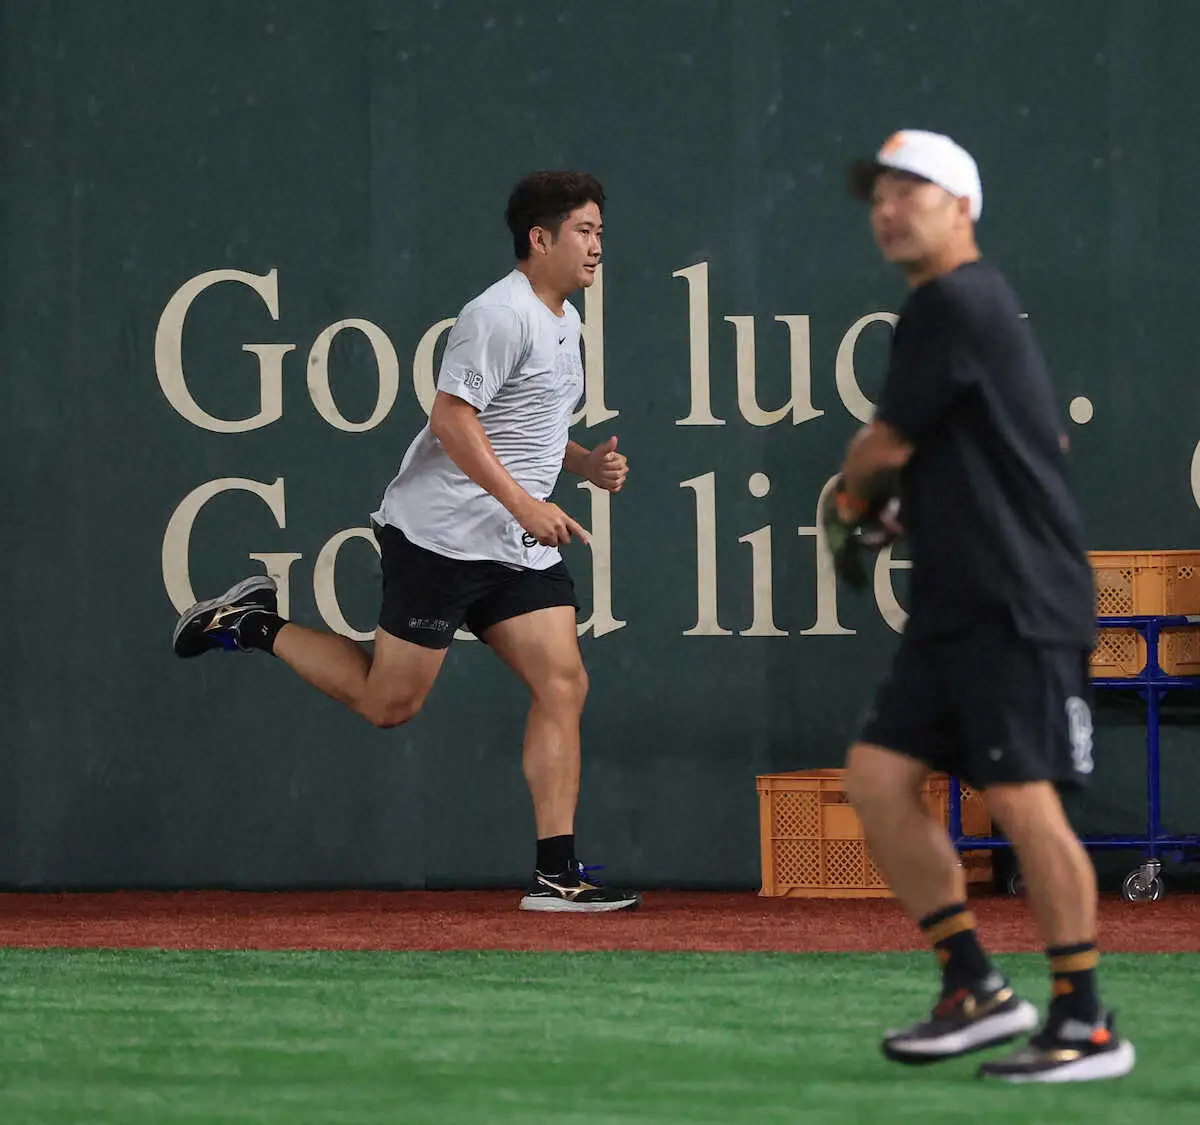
[876,253,1096,648]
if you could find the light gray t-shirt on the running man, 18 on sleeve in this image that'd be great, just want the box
[372,270,583,570]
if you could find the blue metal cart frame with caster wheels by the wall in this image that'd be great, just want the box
[949,614,1200,902]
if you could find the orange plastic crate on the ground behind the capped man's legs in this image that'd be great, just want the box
[756,770,992,898]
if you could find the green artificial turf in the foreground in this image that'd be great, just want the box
[0,949,1200,1125]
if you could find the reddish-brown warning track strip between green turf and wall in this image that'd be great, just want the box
[0,891,1200,952]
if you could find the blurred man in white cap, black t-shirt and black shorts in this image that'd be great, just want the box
[833,130,1134,1082]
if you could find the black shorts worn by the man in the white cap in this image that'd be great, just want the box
[859,624,1093,789]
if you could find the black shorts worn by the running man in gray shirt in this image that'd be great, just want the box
[374,524,580,649]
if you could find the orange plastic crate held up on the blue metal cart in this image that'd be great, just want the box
[1087,551,1200,678]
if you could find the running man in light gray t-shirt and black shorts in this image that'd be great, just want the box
[173,172,641,913]
